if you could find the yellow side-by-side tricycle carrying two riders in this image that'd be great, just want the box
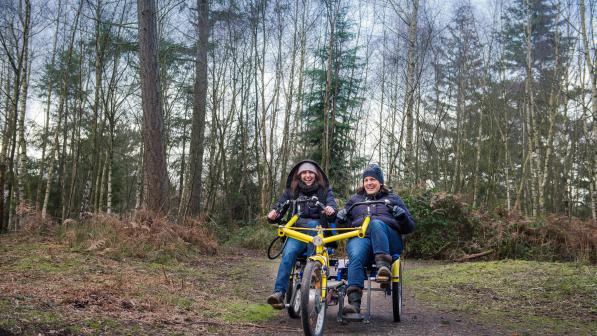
[268,196,402,336]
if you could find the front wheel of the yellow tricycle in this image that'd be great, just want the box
[300,261,327,336]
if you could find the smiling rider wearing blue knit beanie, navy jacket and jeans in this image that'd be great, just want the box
[337,164,415,314]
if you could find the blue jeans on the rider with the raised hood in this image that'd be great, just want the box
[274,220,319,293]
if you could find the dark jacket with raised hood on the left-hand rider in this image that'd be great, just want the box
[272,160,338,224]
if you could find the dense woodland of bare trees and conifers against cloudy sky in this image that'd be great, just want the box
[0,0,597,231]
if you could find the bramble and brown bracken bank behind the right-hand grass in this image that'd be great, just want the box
[398,190,597,264]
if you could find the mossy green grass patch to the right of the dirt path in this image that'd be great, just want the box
[405,260,597,335]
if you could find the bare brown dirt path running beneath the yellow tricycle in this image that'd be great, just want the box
[260,261,513,336]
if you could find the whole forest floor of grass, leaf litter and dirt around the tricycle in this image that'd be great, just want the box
[0,235,597,335]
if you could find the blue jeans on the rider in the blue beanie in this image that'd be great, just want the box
[346,219,403,288]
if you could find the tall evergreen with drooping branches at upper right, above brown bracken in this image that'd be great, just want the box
[501,0,571,215]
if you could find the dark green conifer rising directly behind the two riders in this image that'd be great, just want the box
[302,2,363,195]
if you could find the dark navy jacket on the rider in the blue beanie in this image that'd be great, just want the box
[344,191,415,234]
